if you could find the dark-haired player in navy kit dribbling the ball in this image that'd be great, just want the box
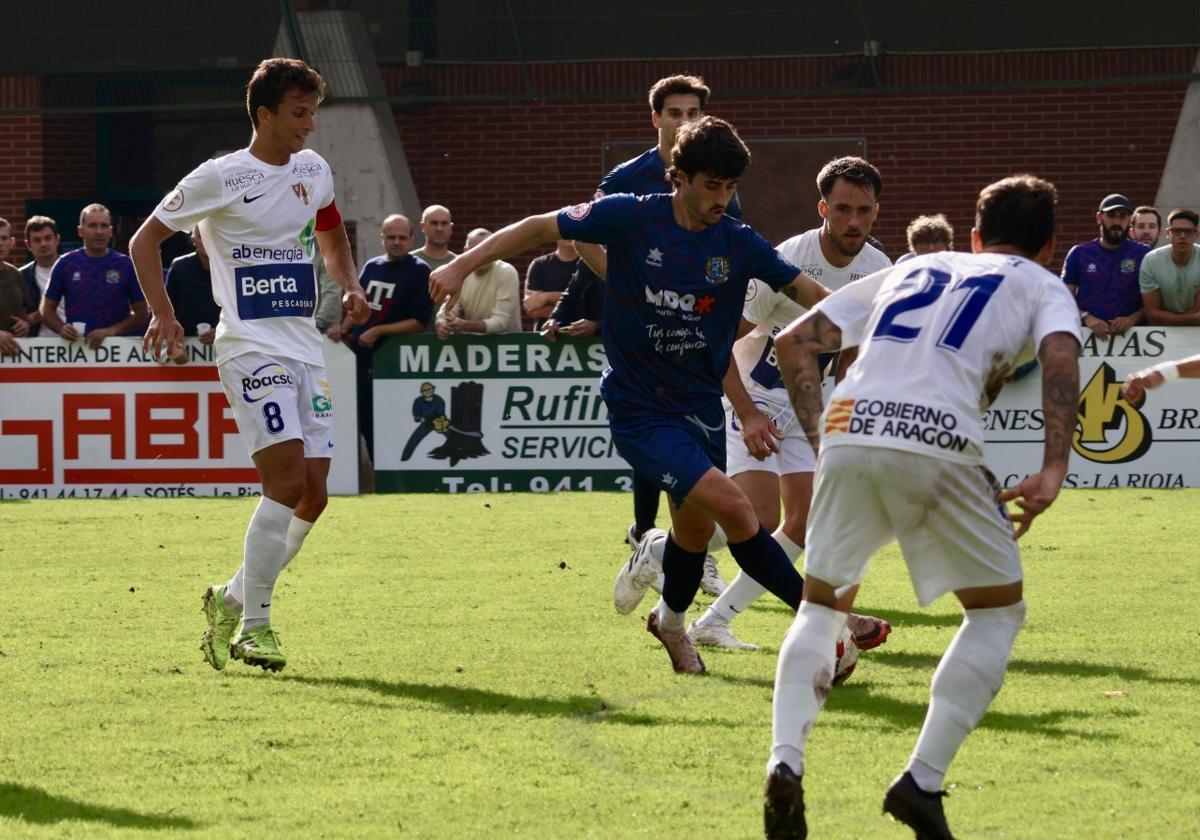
[430,116,833,673]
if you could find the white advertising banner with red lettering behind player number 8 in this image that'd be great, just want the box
[0,337,359,499]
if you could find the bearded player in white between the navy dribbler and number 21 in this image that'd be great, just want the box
[688,157,892,650]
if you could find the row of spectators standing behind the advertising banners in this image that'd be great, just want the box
[0,187,1200,482]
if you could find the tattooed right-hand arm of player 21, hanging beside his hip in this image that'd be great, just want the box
[1000,332,1079,540]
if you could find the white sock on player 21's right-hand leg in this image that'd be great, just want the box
[908,600,1025,791]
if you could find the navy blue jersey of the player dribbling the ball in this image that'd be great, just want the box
[558,194,799,414]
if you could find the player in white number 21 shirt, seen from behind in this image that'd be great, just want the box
[764,175,1080,840]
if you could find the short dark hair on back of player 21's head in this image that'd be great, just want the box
[976,175,1058,259]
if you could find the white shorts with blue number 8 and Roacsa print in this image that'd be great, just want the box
[217,353,334,458]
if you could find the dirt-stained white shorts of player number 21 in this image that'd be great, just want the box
[804,444,1021,606]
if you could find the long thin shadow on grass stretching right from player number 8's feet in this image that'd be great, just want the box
[280,674,678,726]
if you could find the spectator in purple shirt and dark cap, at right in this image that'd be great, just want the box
[1062,193,1150,338]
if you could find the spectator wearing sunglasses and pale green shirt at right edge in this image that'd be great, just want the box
[1138,208,1200,326]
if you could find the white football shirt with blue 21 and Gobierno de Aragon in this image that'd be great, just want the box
[815,251,1079,464]
